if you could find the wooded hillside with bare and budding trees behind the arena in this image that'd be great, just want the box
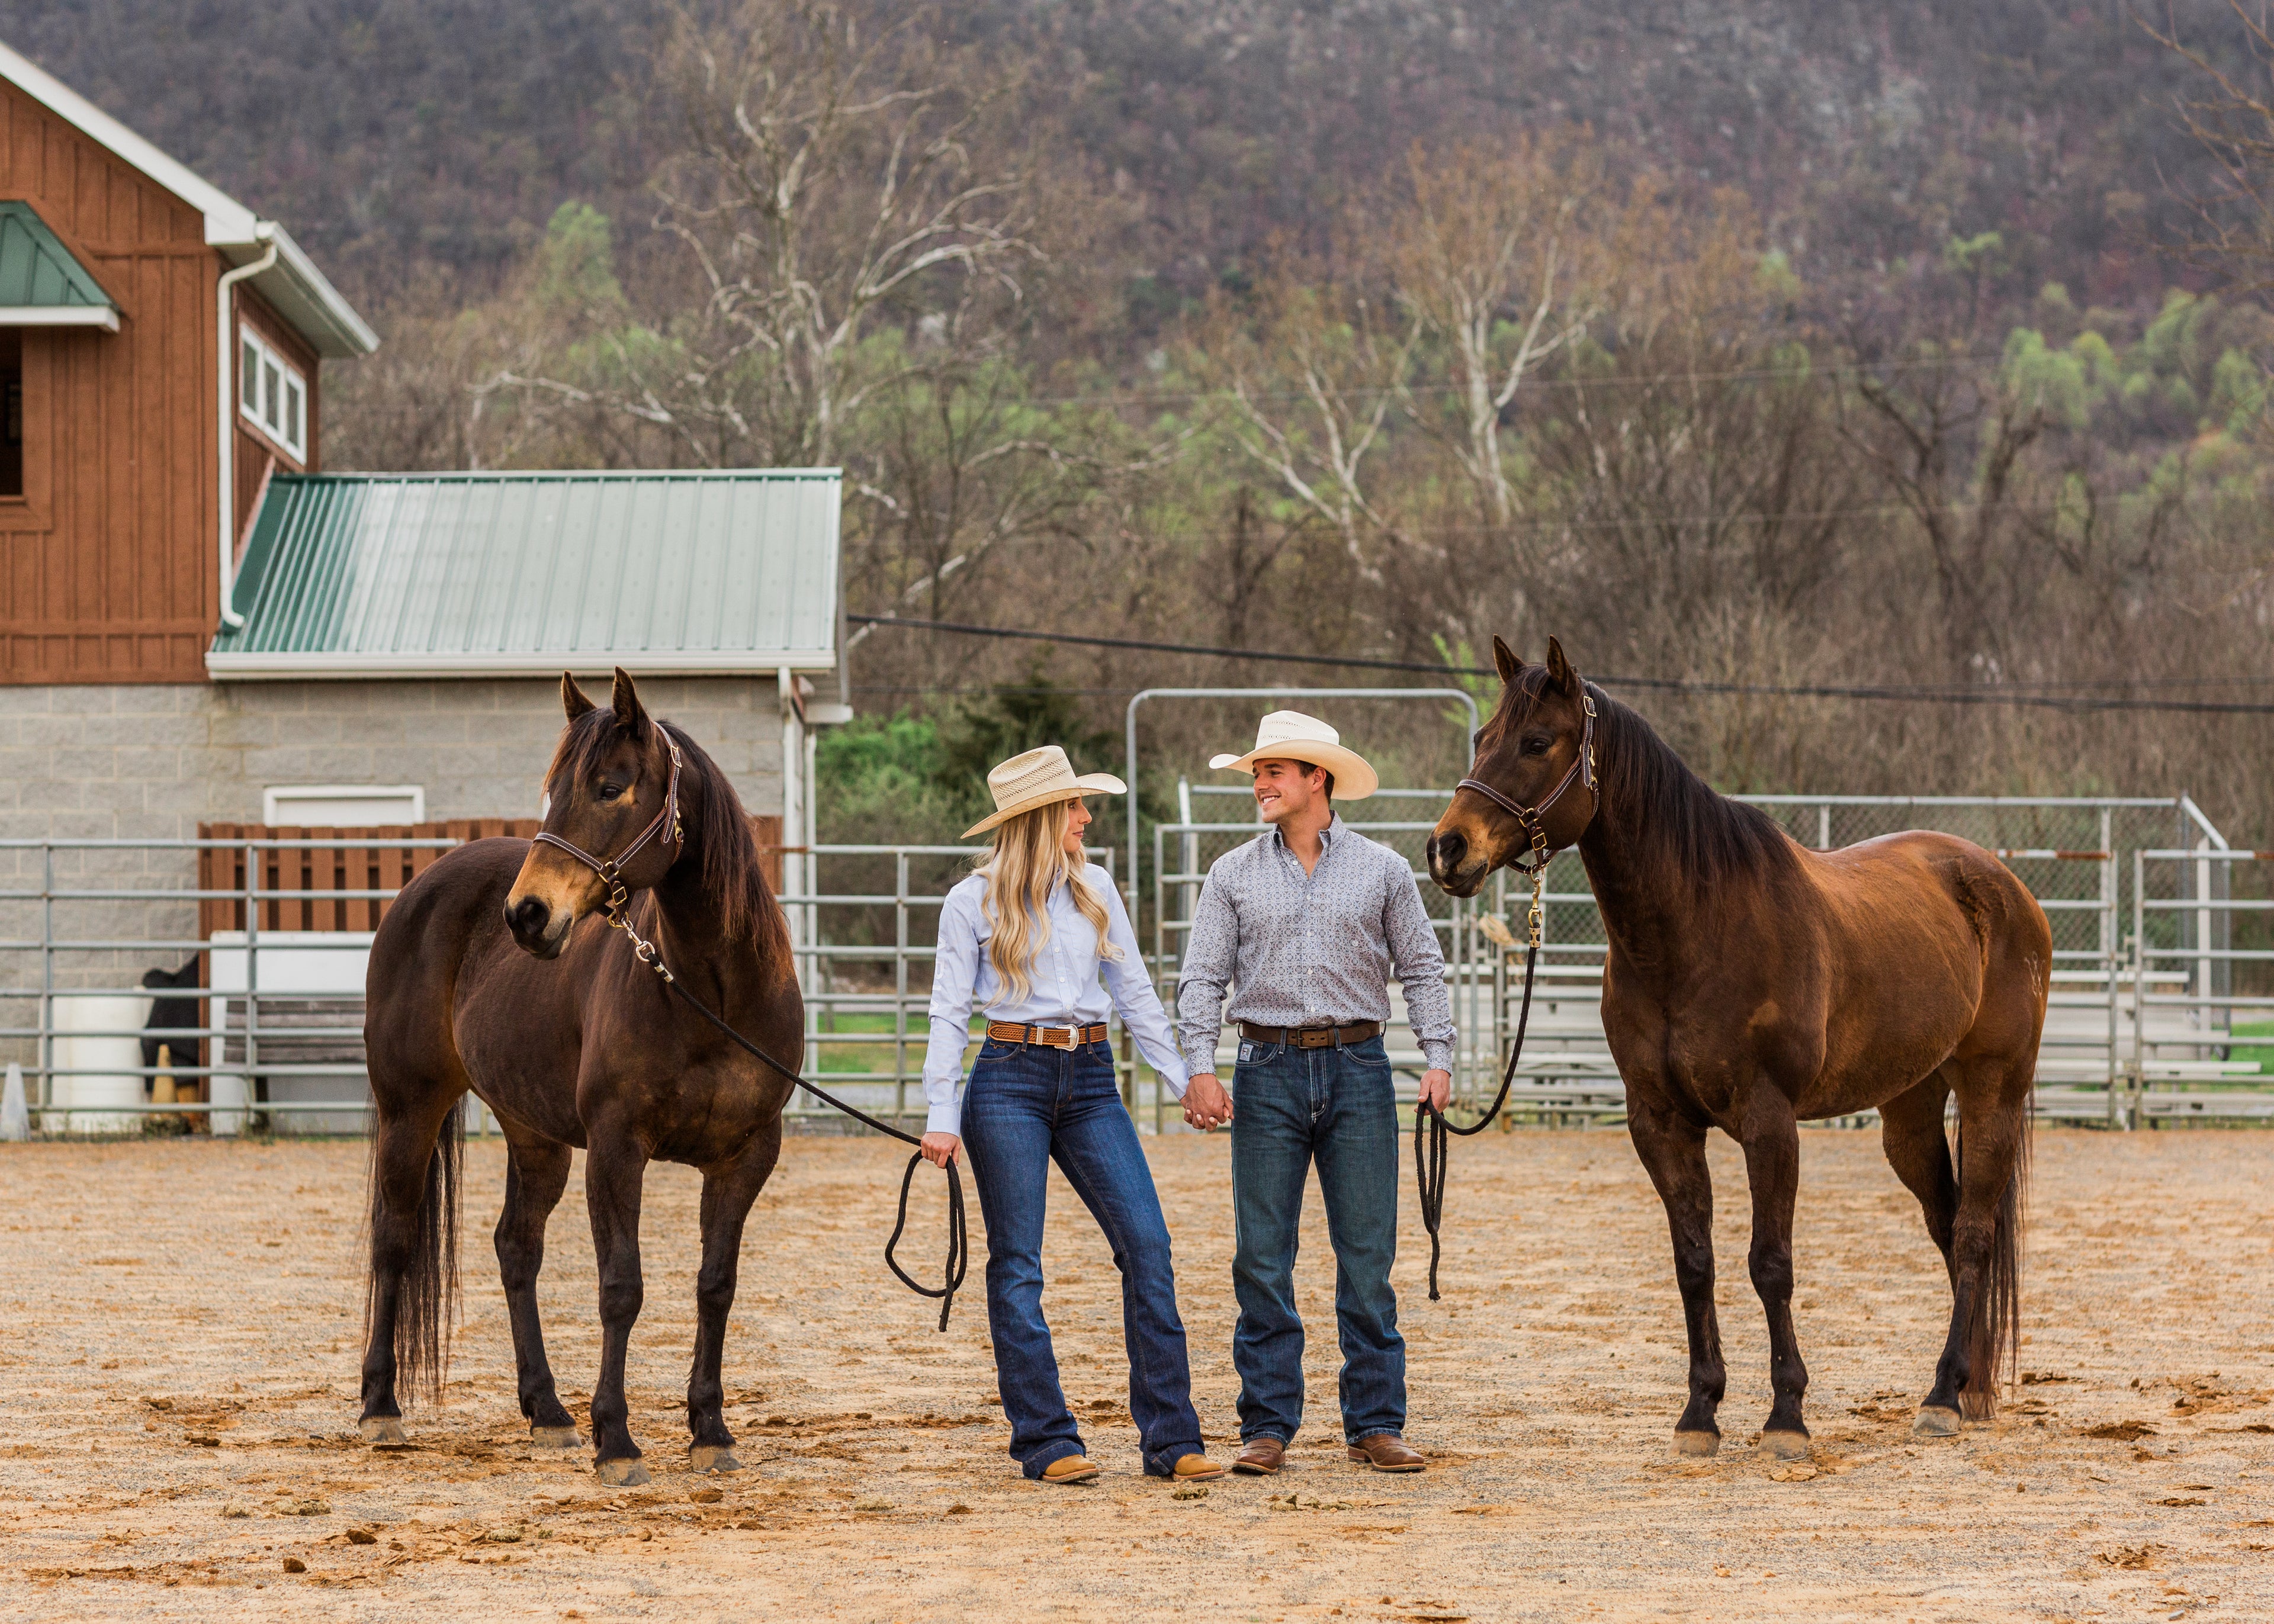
[5,0,2274,844]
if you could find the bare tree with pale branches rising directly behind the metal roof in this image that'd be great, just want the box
[500,0,1039,467]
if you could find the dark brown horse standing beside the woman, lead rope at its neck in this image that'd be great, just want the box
[362,671,805,1483]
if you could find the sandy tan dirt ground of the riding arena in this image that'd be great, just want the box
[0,1130,2274,1619]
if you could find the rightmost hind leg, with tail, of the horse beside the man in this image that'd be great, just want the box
[1915,1056,2033,1438]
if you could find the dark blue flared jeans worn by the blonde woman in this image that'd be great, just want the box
[964,1040,1201,1478]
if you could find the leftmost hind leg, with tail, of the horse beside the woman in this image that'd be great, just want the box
[357,1087,460,1445]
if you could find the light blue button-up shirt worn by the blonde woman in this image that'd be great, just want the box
[923,862,1187,1133]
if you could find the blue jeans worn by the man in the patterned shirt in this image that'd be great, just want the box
[1232,1037,1405,1445]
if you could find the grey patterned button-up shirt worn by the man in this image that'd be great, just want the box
[1175,816,1453,1073]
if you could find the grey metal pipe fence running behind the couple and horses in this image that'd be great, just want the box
[0,783,2274,1133]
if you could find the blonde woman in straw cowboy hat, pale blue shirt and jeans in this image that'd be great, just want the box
[923,744,1223,1483]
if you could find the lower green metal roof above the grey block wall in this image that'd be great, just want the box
[205,468,839,678]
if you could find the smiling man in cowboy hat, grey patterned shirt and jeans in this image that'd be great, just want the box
[1175,710,1453,1476]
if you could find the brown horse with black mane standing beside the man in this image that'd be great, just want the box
[1428,637,2054,1456]
